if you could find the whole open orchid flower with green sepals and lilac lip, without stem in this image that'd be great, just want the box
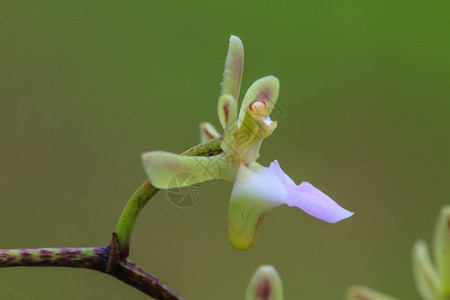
[143,36,353,249]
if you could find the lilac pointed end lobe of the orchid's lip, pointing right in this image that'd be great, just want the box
[286,181,353,223]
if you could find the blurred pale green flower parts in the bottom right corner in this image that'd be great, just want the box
[347,206,450,300]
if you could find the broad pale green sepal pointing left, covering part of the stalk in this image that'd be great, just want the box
[142,151,236,189]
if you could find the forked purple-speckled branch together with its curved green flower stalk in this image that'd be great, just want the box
[0,137,222,300]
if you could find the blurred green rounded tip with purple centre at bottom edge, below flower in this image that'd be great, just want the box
[245,265,283,300]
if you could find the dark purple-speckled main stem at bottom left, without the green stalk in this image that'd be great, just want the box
[0,245,182,300]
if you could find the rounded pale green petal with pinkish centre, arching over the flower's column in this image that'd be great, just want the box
[238,76,280,128]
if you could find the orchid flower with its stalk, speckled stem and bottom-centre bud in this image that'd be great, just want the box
[0,36,353,300]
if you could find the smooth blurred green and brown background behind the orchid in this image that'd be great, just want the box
[0,0,450,300]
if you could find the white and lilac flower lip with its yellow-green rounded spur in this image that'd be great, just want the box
[228,161,353,249]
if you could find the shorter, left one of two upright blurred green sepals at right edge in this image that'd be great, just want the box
[412,240,442,300]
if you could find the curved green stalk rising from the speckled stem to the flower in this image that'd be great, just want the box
[116,137,222,259]
